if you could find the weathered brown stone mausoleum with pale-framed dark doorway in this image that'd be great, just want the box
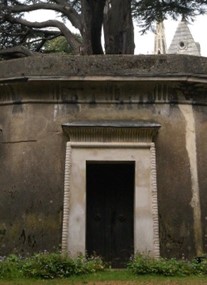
[0,52,207,266]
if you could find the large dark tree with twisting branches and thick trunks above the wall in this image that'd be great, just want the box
[0,0,207,57]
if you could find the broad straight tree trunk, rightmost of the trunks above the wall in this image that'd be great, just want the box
[104,0,134,54]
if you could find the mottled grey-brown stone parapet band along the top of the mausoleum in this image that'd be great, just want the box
[0,55,207,81]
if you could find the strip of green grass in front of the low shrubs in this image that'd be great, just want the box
[0,270,207,285]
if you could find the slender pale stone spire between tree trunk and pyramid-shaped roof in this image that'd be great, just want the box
[154,22,166,54]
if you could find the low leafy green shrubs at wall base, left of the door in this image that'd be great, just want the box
[0,253,105,279]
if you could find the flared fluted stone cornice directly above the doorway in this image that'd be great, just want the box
[62,121,160,142]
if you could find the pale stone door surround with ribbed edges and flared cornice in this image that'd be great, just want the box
[62,121,160,257]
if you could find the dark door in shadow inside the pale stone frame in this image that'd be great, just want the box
[86,163,134,267]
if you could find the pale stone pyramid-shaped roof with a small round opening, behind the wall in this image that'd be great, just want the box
[167,19,200,56]
